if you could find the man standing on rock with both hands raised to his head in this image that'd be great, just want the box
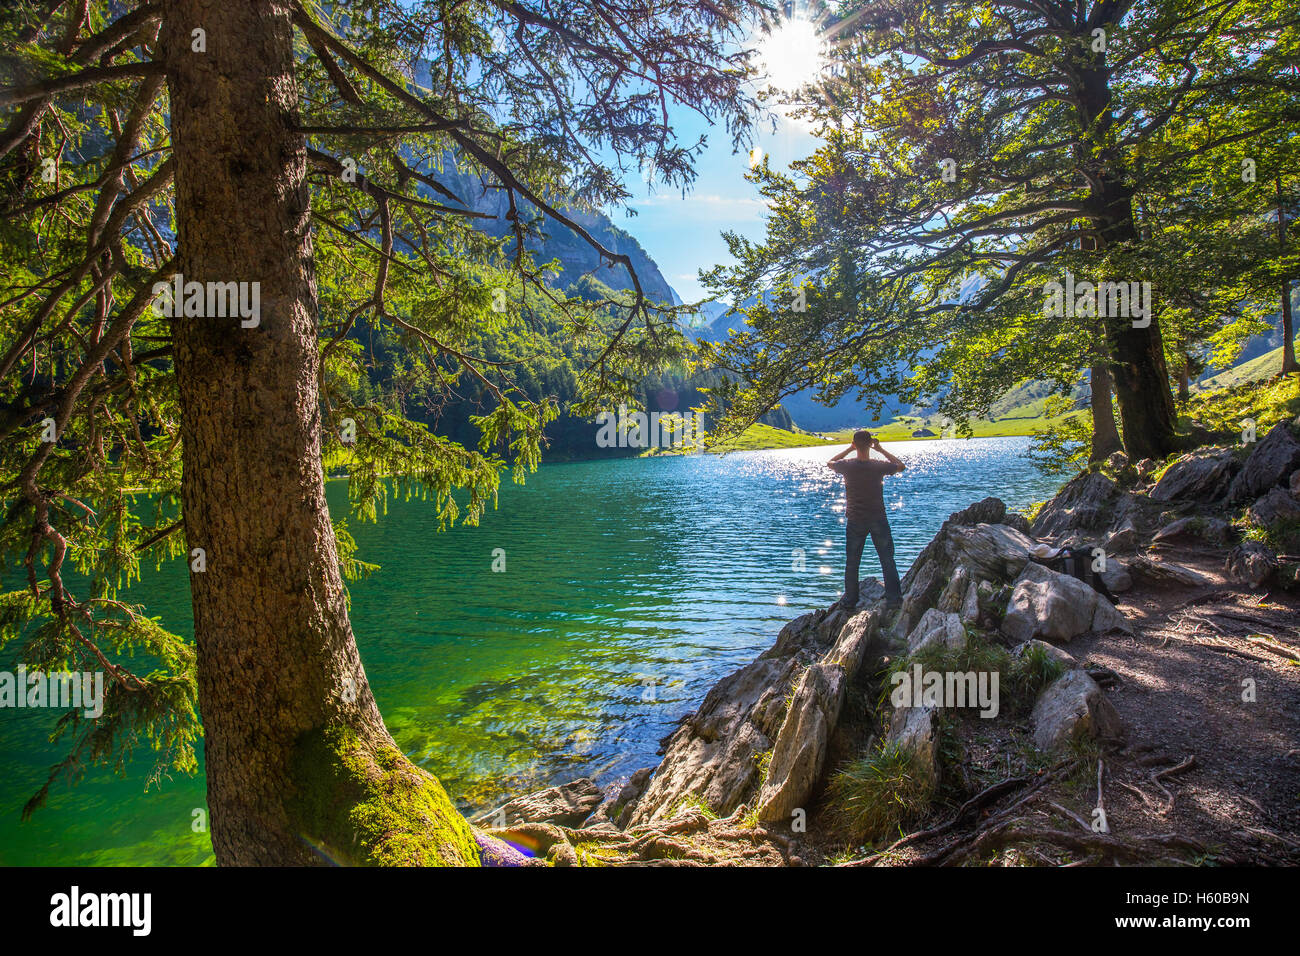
[826,428,907,609]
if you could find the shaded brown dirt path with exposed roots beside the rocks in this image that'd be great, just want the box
[1069,546,1300,865]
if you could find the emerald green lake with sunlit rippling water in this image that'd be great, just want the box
[0,438,1058,865]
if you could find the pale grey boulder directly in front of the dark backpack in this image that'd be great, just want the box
[1002,563,1132,644]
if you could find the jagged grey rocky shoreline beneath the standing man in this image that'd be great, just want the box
[473,420,1300,865]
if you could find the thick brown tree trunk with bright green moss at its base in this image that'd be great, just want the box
[161,0,478,865]
